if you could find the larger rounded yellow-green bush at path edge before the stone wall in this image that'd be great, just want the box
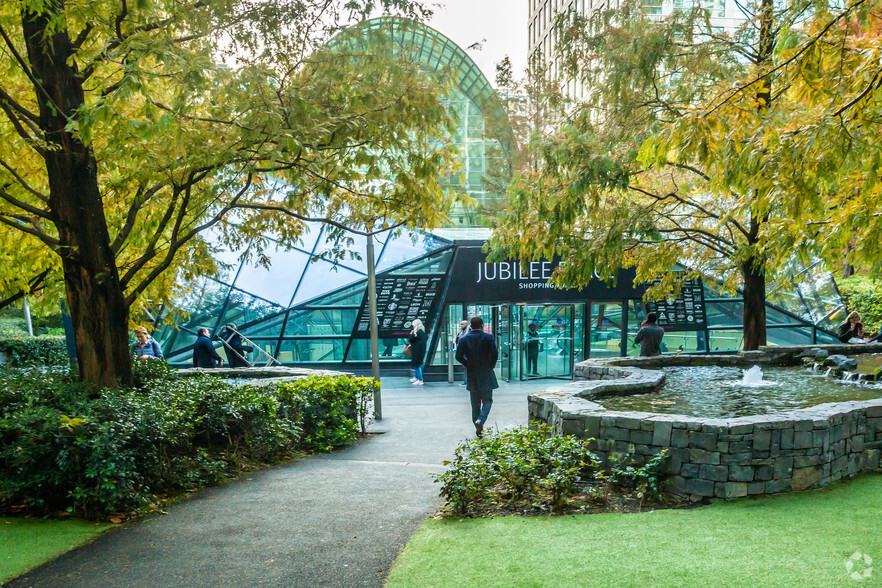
[435,425,598,514]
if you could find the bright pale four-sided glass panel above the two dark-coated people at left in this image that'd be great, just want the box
[235,241,309,307]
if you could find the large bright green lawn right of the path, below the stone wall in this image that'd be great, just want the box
[387,475,882,588]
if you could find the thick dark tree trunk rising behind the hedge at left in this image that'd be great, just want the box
[22,8,132,388]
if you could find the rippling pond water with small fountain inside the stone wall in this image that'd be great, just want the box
[596,366,882,418]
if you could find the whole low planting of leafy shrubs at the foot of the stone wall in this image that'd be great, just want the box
[435,425,679,516]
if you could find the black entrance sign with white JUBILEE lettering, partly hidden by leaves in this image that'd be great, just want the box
[447,246,645,304]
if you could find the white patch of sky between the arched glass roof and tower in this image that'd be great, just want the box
[428,0,529,86]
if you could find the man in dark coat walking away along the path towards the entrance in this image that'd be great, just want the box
[456,316,499,437]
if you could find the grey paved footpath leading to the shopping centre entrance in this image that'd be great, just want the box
[7,378,548,588]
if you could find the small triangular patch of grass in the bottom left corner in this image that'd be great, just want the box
[0,518,110,584]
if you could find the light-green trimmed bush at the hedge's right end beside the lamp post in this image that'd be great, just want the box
[277,376,380,451]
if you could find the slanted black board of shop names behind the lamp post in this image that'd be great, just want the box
[352,274,445,339]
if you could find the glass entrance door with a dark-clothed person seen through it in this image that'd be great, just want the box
[519,304,575,380]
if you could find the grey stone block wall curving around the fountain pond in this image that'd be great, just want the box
[528,361,882,500]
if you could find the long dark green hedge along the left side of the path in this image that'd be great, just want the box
[0,361,367,518]
